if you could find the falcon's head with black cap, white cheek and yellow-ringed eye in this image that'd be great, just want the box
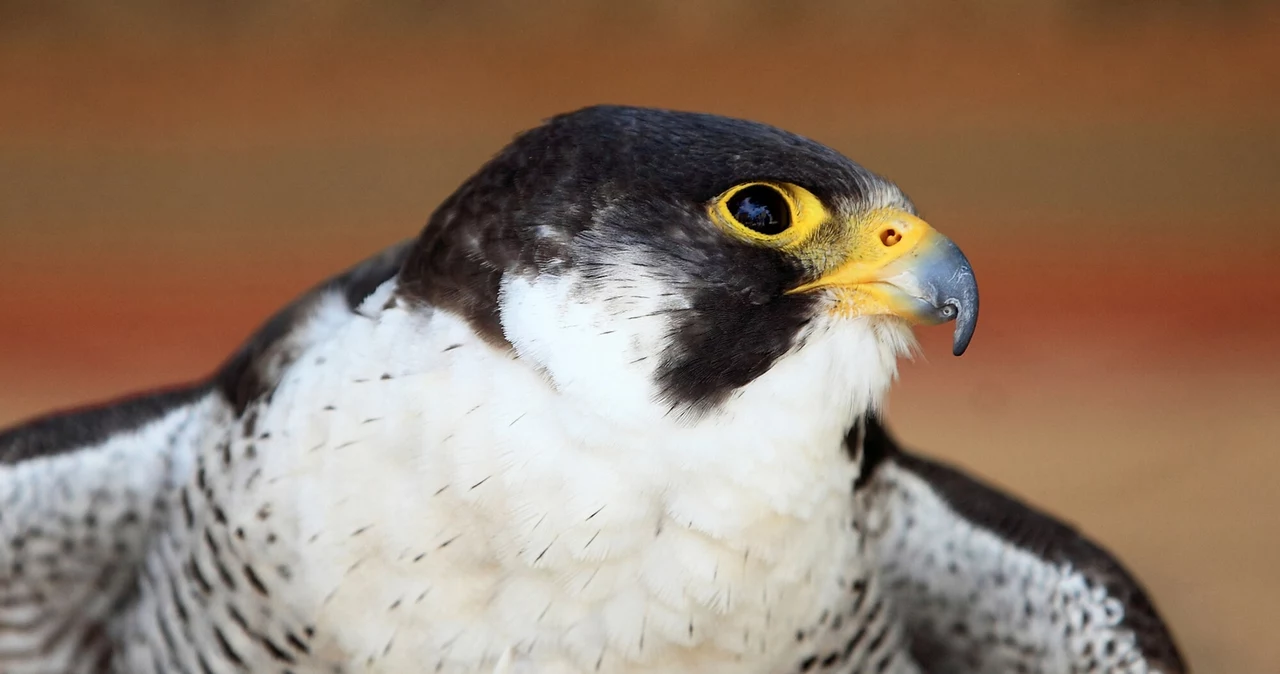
[401,106,978,423]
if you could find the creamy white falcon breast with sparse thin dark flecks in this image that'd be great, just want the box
[209,282,892,673]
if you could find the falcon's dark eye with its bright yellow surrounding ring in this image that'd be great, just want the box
[708,180,827,248]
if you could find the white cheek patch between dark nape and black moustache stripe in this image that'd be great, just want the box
[498,265,687,422]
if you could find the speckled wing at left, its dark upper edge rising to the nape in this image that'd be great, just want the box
[0,242,412,674]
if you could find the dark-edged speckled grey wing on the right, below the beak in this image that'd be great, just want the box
[860,419,1187,674]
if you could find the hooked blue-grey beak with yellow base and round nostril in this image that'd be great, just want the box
[791,208,978,356]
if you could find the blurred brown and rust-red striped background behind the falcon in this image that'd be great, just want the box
[0,0,1280,674]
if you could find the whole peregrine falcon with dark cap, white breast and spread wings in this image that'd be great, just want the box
[0,106,1184,674]
